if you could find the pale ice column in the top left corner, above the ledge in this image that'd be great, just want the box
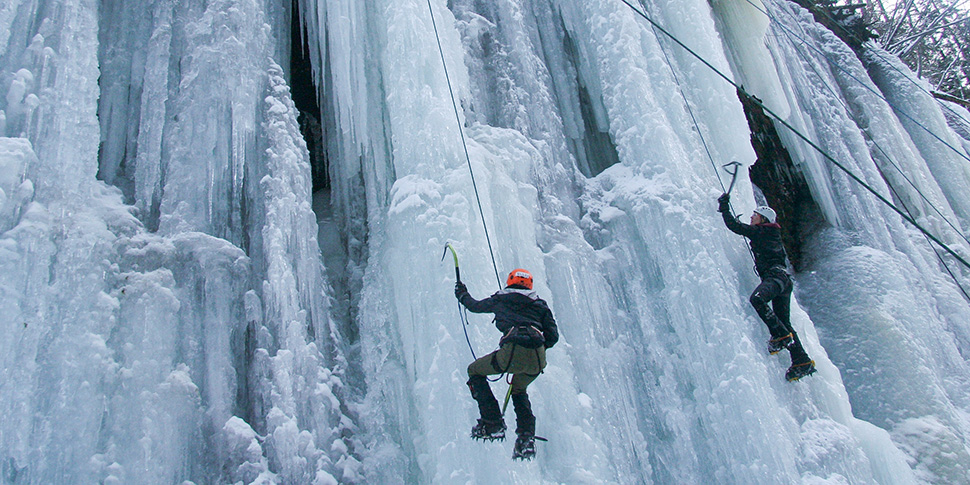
[0,0,100,199]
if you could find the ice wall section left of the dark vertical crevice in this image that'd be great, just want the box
[0,0,358,483]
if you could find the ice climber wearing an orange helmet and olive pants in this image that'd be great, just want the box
[455,269,559,459]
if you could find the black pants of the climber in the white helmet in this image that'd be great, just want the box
[750,267,811,364]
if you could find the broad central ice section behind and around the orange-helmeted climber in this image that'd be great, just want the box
[308,1,952,483]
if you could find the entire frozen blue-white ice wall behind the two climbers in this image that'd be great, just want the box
[0,0,970,483]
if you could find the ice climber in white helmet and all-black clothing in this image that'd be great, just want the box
[717,194,815,381]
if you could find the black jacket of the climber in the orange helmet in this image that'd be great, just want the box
[458,288,559,348]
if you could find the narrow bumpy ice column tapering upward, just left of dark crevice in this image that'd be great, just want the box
[247,64,358,482]
